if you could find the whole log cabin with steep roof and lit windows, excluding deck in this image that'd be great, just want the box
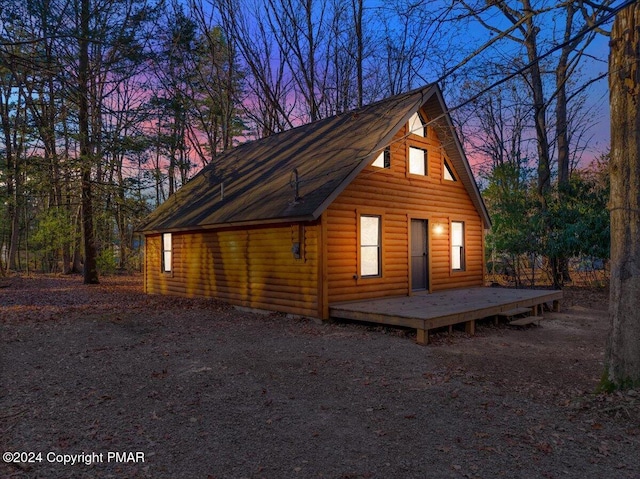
[140,85,490,319]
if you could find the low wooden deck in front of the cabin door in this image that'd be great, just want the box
[329,288,562,344]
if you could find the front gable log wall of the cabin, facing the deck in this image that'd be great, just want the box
[323,118,484,303]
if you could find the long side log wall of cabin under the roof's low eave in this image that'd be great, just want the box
[145,224,322,317]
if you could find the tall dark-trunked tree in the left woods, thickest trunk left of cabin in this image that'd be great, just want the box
[71,0,152,284]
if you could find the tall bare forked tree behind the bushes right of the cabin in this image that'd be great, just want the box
[462,0,609,287]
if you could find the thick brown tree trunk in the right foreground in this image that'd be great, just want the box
[603,3,640,388]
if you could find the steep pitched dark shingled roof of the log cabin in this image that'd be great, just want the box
[139,85,490,233]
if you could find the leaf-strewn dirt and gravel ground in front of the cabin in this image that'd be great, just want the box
[0,277,640,479]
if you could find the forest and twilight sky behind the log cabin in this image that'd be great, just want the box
[0,0,633,287]
